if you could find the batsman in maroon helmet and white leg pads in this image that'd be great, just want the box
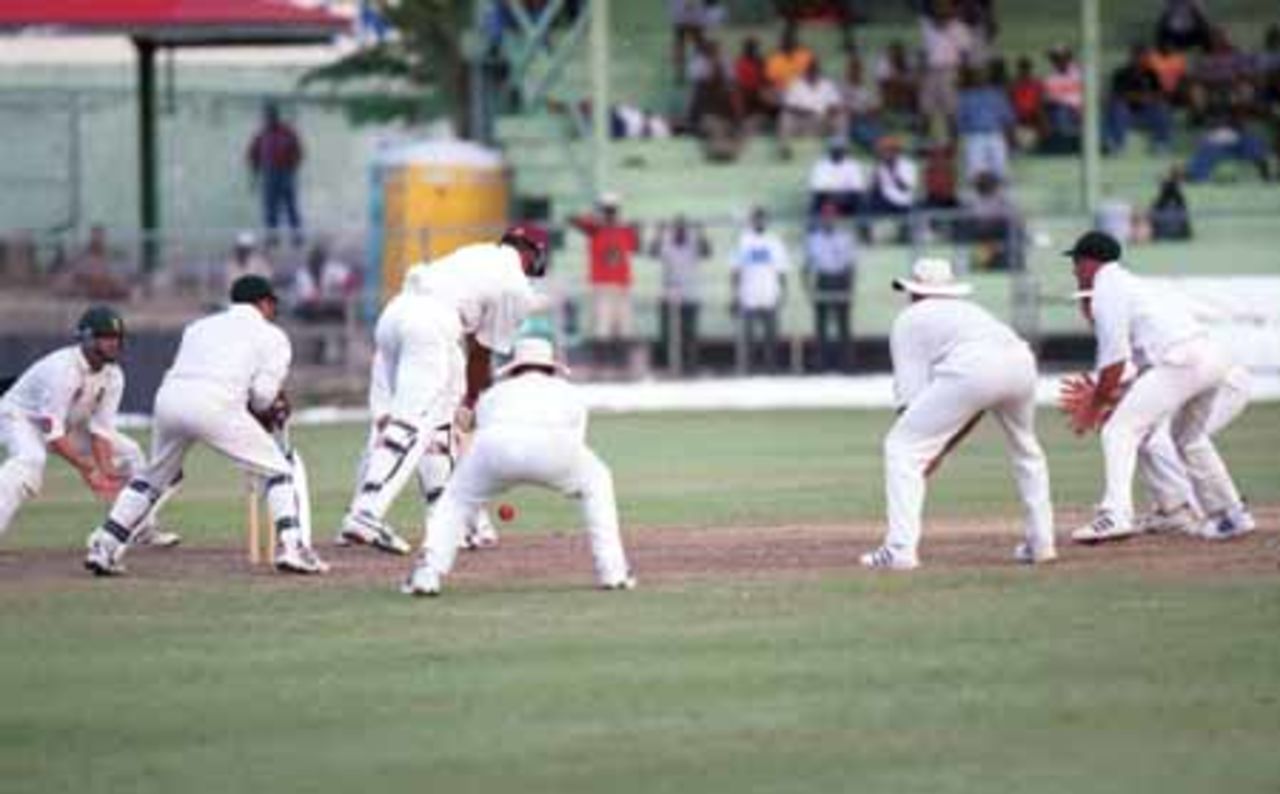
[339,227,547,555]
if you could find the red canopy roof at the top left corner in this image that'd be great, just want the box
[0,0,351,44]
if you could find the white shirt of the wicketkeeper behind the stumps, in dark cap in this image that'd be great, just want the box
[165,304,293,410]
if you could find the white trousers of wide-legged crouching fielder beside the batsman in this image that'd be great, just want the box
[424,425,628,584]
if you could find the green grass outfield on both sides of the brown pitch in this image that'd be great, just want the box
[0,406,1280,794]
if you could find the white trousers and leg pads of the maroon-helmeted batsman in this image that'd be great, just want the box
[348,301,466,520]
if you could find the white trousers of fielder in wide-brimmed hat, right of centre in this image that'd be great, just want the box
[884,346,1053,560]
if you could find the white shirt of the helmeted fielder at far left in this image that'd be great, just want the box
[0,344,124,441]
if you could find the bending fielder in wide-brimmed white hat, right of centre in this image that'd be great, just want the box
[861,259,1057,570]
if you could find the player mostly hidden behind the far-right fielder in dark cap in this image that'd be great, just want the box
[1075,289,1251,539]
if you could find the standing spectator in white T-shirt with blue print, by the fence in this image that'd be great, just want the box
[731,207,791,371]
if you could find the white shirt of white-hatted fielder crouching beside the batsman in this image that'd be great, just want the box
[476,370,586,443]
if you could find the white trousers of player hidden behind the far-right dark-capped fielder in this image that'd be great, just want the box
[1138,368,1249,512]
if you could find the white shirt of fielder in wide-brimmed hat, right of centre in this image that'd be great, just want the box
[890,297,1027,406]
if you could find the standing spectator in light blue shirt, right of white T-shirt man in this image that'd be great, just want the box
[805,204,858,371]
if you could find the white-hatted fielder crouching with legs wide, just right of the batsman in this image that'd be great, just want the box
[401,337,636,596]
